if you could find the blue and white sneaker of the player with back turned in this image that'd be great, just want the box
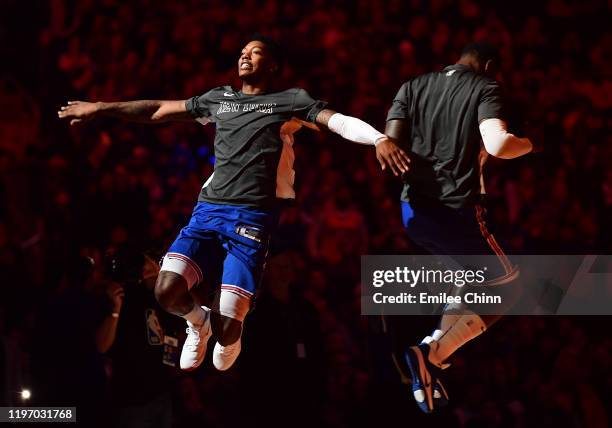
[406,343,440,413]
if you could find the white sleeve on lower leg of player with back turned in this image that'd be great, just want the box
[429,314,487,367]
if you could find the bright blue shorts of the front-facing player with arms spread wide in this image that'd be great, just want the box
[162,202,278,299]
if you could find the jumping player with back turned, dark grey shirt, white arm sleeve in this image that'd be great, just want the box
[385,44,532,413]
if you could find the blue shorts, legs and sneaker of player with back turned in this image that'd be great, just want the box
[403,201,518,412]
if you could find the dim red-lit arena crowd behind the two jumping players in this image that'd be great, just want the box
[0,0,612,427]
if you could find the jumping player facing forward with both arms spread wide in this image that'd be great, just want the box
[58,35,409,370]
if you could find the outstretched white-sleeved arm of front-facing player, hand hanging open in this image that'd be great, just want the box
[316,109,410,175]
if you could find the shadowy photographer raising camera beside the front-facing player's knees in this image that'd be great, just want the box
[96,249,181,428]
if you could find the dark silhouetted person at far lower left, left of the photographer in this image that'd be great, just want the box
[28,249,107,428]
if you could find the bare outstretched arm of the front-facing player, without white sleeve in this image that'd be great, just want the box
[57,100,194,125]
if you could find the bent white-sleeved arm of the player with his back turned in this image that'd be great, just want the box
[480,119,533,159]
